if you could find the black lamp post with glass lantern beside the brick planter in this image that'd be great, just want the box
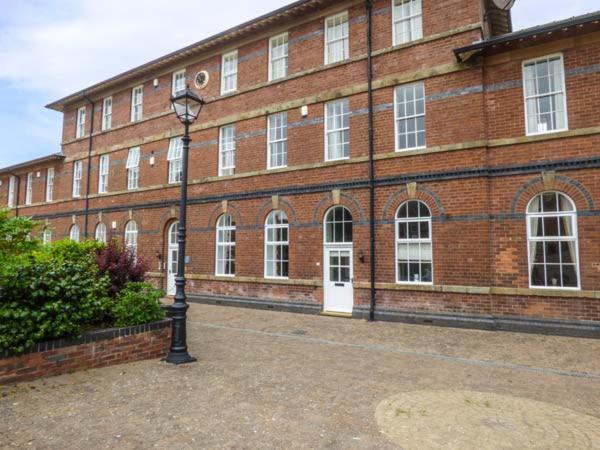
[166,86,204,364]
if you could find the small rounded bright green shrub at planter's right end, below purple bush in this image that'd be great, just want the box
[111,282,165,327]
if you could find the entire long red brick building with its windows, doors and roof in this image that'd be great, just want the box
[0,0,600,335]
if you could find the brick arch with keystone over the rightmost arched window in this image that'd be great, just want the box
[510,175,596,214]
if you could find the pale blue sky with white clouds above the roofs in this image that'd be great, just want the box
[0,0,600,167]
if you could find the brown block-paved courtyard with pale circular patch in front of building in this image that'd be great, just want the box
[0,305,600,449]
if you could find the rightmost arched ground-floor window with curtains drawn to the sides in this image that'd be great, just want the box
[527,192,579,288]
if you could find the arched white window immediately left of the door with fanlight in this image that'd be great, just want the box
[265,210,289,278]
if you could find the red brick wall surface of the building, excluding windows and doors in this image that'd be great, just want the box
[0,0,600,330]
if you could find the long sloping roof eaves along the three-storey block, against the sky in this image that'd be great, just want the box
[46,0,335,112]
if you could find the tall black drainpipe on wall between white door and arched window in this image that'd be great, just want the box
[365,0,377,322]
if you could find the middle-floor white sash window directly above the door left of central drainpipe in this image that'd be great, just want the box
[325,99,350,161]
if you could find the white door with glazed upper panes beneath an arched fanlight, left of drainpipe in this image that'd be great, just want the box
[323,246,354,313]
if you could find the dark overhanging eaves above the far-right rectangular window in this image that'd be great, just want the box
[454,11,600,62]
